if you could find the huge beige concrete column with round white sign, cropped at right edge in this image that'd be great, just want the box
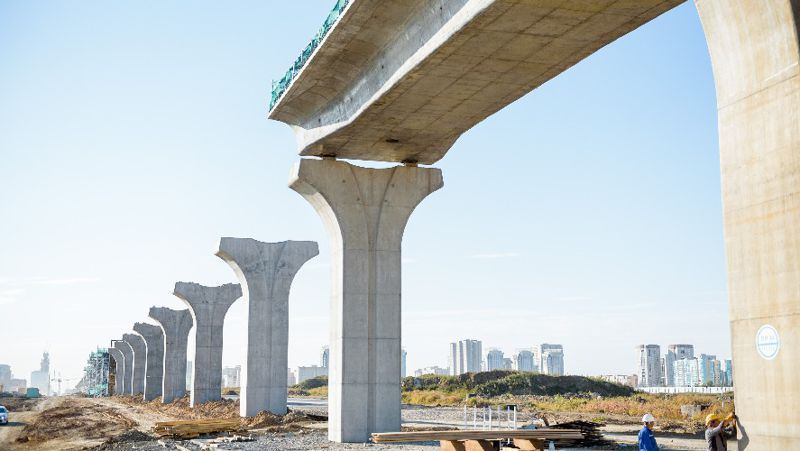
[695,0,800,450]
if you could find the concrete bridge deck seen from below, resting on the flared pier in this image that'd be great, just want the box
[269,0,680,164]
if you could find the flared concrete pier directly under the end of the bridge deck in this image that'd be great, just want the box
[290,159,443,442]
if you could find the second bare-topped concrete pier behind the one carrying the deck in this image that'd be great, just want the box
[173,282,242,407]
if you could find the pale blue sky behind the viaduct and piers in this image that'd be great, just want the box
[0,0,730,388]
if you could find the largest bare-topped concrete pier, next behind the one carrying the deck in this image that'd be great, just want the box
[217,238,319,417]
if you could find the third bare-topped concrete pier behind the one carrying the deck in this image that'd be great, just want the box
[150,307,194,403]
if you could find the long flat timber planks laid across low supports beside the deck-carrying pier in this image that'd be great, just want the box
[372,428,583,443]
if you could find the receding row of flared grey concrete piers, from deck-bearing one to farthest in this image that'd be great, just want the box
[102,158,443,442]
